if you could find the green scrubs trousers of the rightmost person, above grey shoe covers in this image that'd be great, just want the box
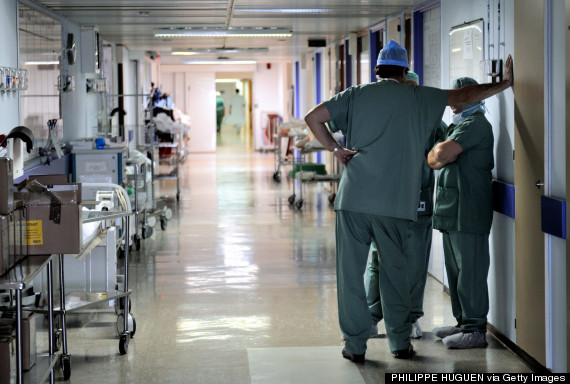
[442,231,490,333]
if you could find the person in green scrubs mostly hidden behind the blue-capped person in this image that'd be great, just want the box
[365,71,447,339]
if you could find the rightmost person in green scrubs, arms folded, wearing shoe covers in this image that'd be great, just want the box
[428,77,494,348]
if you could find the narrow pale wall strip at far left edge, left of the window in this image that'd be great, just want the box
[0,0,20,134]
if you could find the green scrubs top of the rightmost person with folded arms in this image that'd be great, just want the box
[433,112,494,234]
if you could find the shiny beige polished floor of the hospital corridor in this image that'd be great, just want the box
[42,125,531,384]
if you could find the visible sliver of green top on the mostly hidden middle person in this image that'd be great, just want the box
[418,121,447,224]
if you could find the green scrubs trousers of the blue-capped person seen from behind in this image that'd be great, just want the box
[336,210,412,354]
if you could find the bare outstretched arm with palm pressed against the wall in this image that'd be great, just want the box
[447,55,513,105]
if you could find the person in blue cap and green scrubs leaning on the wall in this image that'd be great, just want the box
[305,41,512,363]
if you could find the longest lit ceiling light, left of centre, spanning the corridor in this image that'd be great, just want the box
[154,28,293,37]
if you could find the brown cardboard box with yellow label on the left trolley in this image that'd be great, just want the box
[14,184,83,255]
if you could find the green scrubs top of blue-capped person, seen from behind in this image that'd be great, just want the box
[325,80,449,221]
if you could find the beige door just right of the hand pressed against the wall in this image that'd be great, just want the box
[513,0,546,365]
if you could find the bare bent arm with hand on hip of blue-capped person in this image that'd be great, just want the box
[305,103,358,165]
